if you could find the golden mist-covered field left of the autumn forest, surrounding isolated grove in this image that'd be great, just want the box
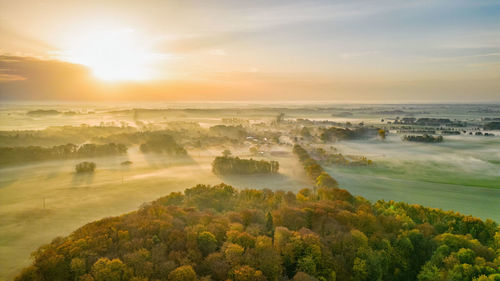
[0,144,310,279]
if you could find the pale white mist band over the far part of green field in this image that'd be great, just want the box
[334,135,500,177]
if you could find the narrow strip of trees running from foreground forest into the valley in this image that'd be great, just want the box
[293,144,339,188]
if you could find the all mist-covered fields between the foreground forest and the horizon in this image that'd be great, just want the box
[0,101,500,278]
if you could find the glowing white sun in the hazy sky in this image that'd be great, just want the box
[64,28,155,81]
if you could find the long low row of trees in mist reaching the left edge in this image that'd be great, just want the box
[0,143,127,165]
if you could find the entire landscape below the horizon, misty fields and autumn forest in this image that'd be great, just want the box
[0,103,500,281]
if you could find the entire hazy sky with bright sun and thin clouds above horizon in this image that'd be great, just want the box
[0,0,500,102]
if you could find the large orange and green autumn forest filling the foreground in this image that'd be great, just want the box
[15,184,500,281]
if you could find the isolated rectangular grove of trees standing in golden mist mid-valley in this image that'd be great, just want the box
[212,156,279,175]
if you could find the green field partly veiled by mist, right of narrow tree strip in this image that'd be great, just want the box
[325,136,500,221]
